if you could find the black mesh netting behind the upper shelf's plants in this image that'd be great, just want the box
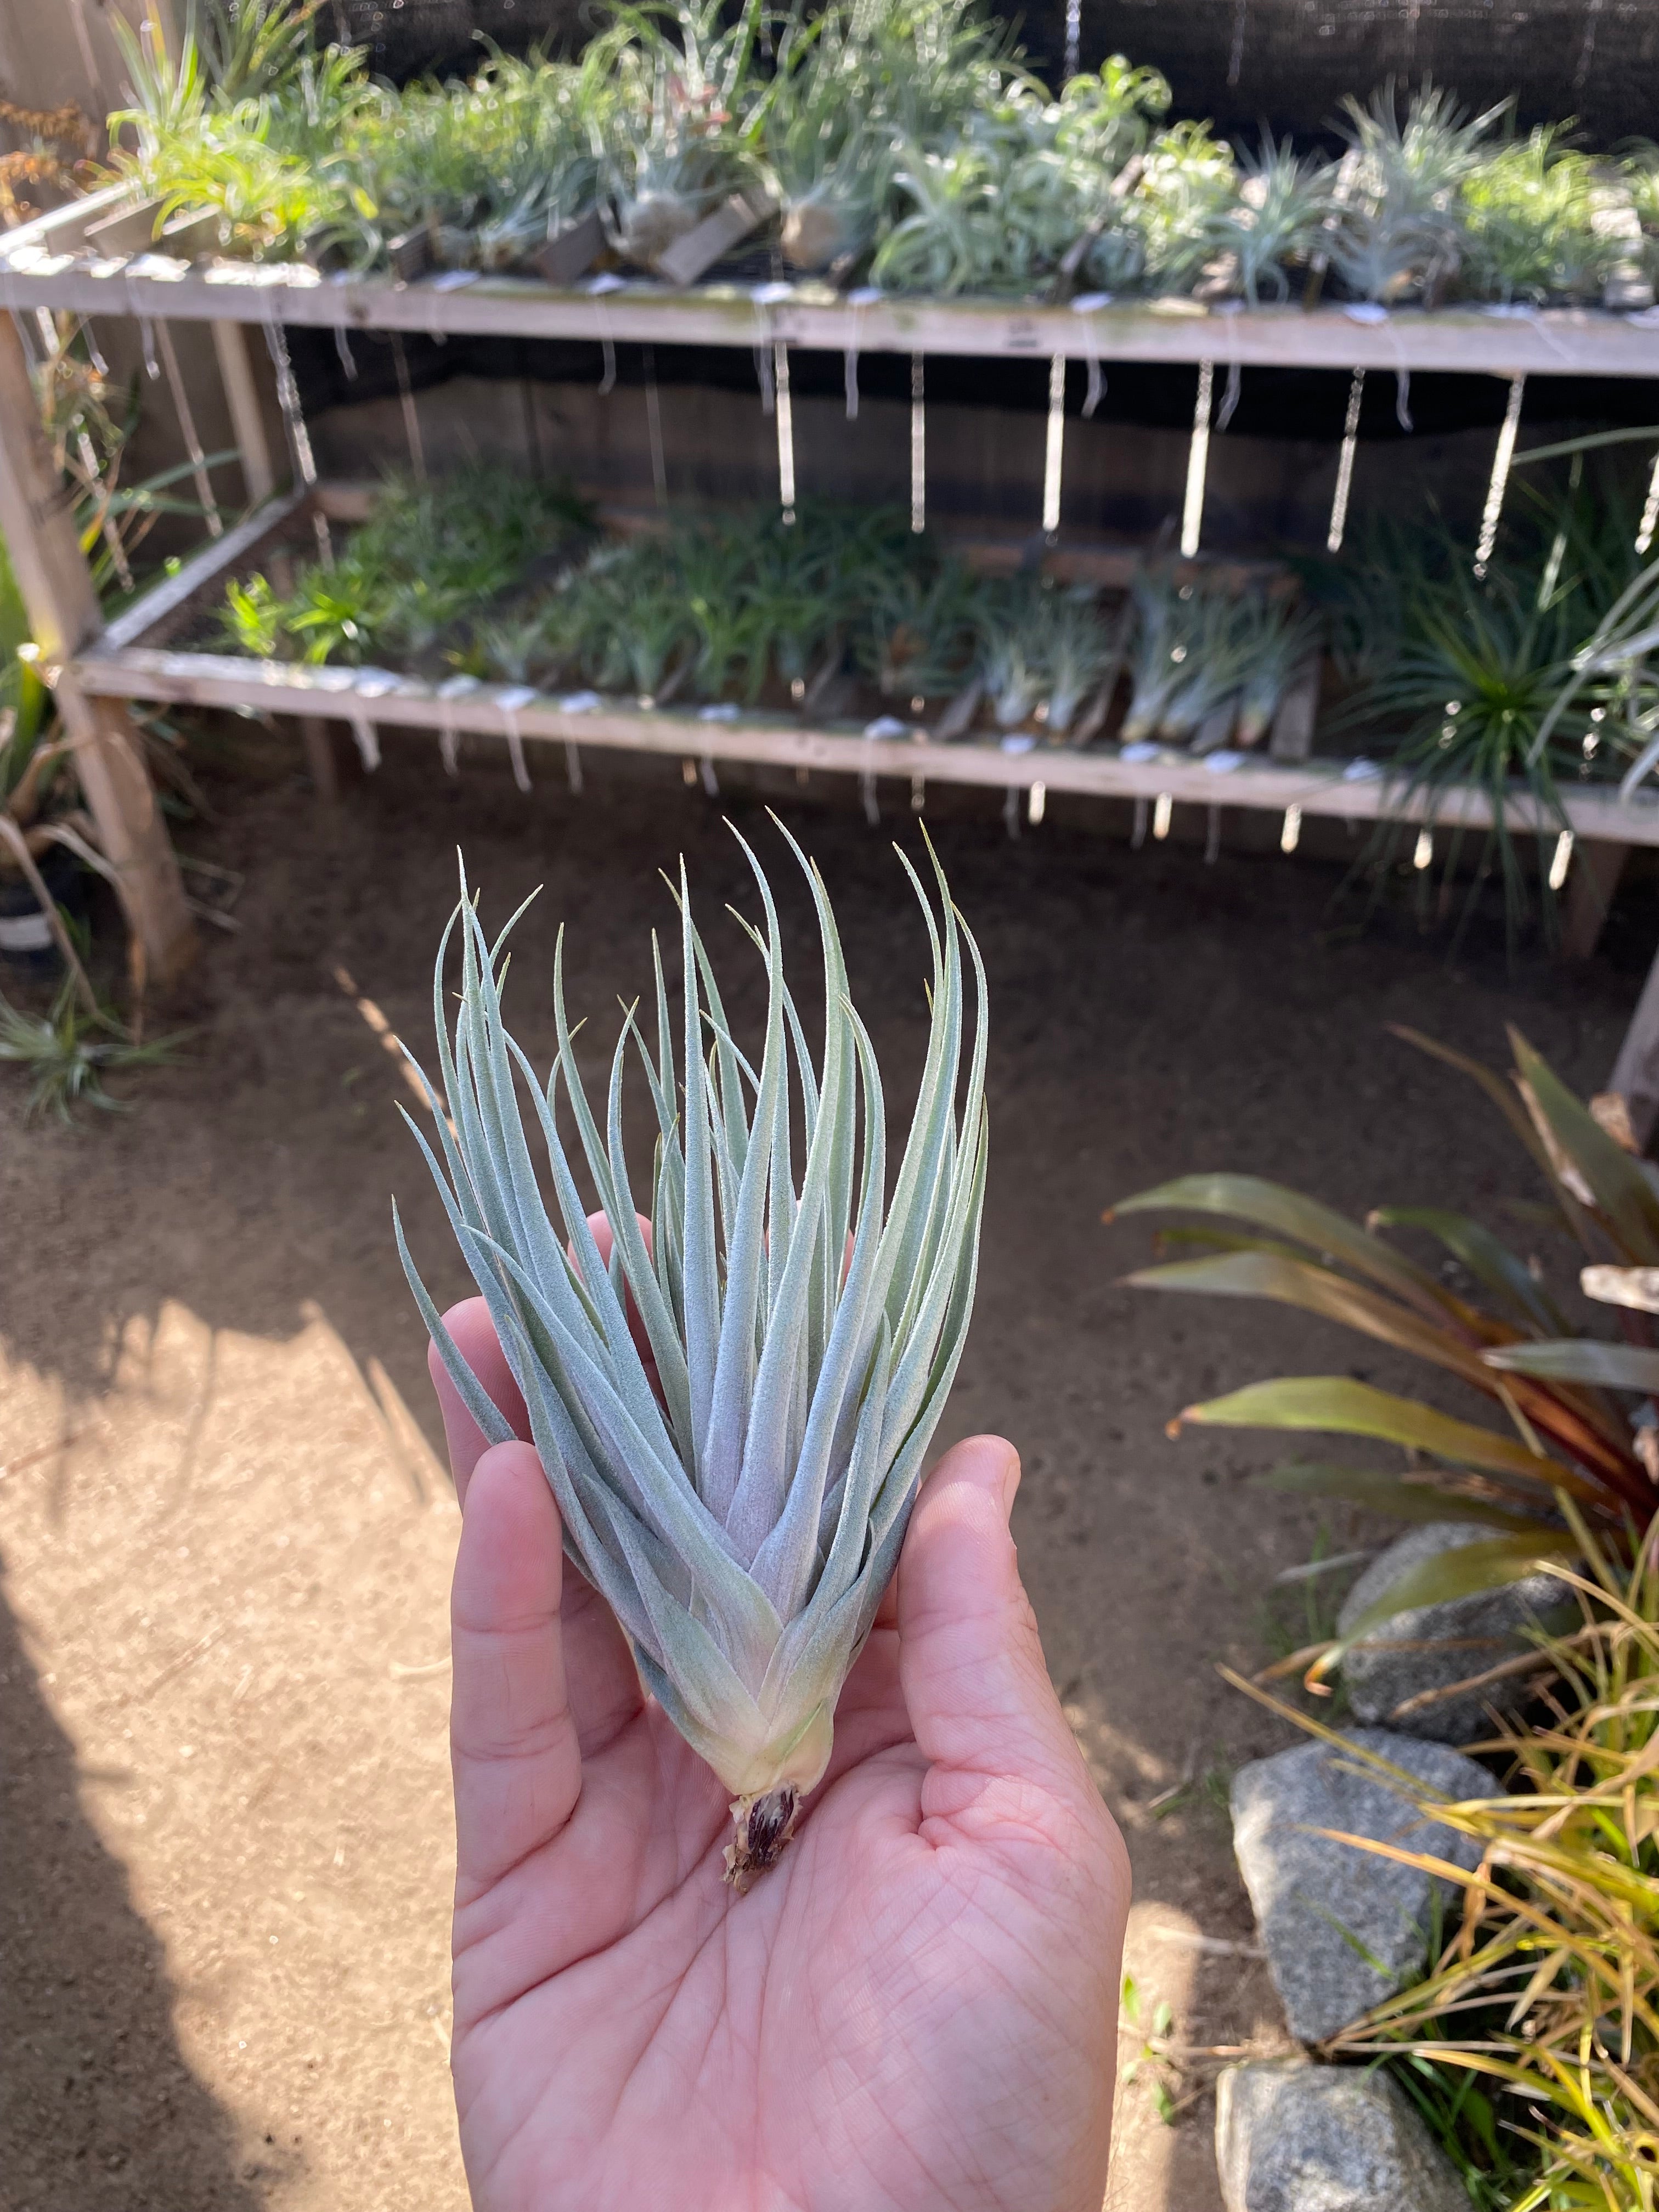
[323,0,1659,146]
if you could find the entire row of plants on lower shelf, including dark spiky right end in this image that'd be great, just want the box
[169,458,1659,818]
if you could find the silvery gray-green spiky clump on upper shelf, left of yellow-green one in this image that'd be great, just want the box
[1329,82,1506,305]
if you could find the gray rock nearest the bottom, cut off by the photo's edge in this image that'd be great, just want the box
[1215,2059,1469,2212]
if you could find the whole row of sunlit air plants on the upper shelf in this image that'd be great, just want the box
[100,0,1659,309]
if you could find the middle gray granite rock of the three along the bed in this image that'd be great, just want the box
[1232,1728,1498,2044]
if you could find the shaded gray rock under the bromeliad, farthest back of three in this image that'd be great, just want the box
[1336,1522,1562,1743]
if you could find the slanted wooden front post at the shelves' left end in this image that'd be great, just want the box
[0,314,197,982]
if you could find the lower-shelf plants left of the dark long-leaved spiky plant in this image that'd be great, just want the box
[188,467,1325,752]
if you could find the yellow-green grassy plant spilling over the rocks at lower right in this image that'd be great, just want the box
[1232,1498,1659,2212]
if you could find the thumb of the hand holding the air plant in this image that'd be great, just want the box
[898,1436,1095,1809]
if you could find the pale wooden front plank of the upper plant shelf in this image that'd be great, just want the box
[0,195,1659,378]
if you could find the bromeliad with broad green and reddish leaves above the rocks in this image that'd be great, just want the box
[1115,1029,1659,1679]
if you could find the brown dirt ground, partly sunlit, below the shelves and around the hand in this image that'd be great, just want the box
[0,732,1655,2212]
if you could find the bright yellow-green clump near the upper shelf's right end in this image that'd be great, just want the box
[1460,128,1628,305]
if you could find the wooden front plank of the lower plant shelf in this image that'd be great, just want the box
[71,646,1659,845]
